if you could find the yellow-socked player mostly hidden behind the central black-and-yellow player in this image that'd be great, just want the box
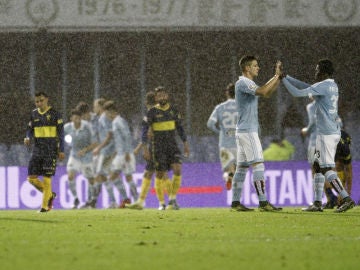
[125,91,172,210]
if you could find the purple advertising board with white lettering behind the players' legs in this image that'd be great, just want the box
[0,161,360,210]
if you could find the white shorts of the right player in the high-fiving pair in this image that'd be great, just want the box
[315,134,340,168]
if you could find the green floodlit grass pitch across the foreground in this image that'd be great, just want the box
[0,207,360,270]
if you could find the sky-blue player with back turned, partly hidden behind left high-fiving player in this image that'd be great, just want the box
[207,83,238,190]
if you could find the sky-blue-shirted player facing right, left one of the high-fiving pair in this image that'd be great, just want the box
[231,55,282,211]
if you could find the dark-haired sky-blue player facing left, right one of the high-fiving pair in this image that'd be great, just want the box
[282,59,355,212]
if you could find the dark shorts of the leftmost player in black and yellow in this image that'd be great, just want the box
[28,155,56,176]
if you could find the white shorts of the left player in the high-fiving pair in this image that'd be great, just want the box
[235,132,264,166]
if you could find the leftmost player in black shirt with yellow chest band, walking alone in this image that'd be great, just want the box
[24,92,65,213]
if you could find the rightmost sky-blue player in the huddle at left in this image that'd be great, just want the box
[104,100,138,208]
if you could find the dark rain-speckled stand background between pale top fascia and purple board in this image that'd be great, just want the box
[0,27,360,145]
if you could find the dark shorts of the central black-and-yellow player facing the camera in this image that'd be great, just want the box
[154,144,182,172]
